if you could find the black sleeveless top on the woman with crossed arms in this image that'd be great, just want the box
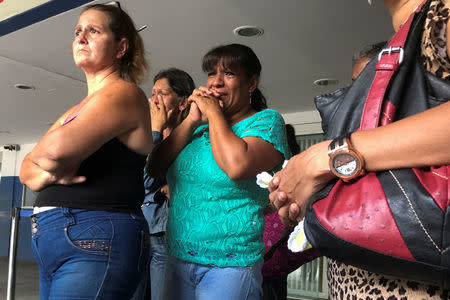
[35,138,146,212]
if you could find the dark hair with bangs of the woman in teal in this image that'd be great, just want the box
[202,44,267,111]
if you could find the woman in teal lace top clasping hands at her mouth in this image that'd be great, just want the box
[150,44,289,300]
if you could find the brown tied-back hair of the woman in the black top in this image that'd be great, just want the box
[83,4,148,83]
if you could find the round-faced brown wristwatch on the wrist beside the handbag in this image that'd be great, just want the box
[328,134,365,182]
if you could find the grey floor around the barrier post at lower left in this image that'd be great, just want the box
[0,257,39,300]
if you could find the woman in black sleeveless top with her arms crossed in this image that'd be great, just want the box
[20,3,153,299]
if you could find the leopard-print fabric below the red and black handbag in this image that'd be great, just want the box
[327,259,450,300]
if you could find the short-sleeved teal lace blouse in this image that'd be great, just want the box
[166,109,290,267]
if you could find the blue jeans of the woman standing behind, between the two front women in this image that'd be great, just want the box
[133,233,167,300]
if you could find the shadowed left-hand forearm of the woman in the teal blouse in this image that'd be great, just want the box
[145,119,198,178]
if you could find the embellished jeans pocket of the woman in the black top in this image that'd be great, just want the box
[64,219,113,255]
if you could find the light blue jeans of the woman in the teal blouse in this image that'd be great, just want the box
[164,256,263,300]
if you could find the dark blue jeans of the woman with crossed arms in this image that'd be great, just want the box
[31,208,149,300]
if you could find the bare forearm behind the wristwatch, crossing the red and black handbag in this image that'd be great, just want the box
[351,103,450,171]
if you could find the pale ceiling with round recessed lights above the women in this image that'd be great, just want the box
[0,0,392,145]
